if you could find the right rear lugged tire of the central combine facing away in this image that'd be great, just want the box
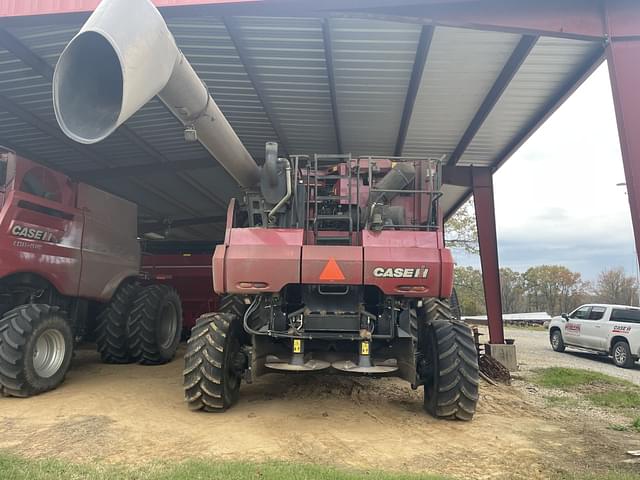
[418,299,480,421]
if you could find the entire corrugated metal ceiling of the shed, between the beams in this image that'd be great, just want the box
[0,8,608,231]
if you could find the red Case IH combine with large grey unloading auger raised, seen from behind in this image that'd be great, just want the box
[54,0,479,420]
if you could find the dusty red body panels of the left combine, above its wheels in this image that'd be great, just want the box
[0,154,139,301]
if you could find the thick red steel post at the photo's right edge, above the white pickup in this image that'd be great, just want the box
[607,38,640,274]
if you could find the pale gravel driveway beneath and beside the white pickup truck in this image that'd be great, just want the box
[498,328,640,385]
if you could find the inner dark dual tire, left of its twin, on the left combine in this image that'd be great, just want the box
[96,282,140,364]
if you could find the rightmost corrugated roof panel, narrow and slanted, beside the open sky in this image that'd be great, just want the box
[458,37,599,166]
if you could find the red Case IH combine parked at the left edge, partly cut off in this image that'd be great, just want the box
[0,152,182,397]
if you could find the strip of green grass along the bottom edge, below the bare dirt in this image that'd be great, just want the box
[0,453,445,480]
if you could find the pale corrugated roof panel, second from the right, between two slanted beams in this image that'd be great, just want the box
[403,27,520,156]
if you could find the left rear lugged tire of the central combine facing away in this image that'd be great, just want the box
[183,313,246,412]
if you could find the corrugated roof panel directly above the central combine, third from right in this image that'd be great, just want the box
[331,18,421,155]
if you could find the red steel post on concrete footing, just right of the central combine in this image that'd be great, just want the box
[471,168,504,344]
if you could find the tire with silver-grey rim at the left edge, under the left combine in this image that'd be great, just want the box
[0,304,73,397]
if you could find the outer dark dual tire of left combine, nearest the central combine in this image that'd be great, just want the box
[127,285,182,365]
